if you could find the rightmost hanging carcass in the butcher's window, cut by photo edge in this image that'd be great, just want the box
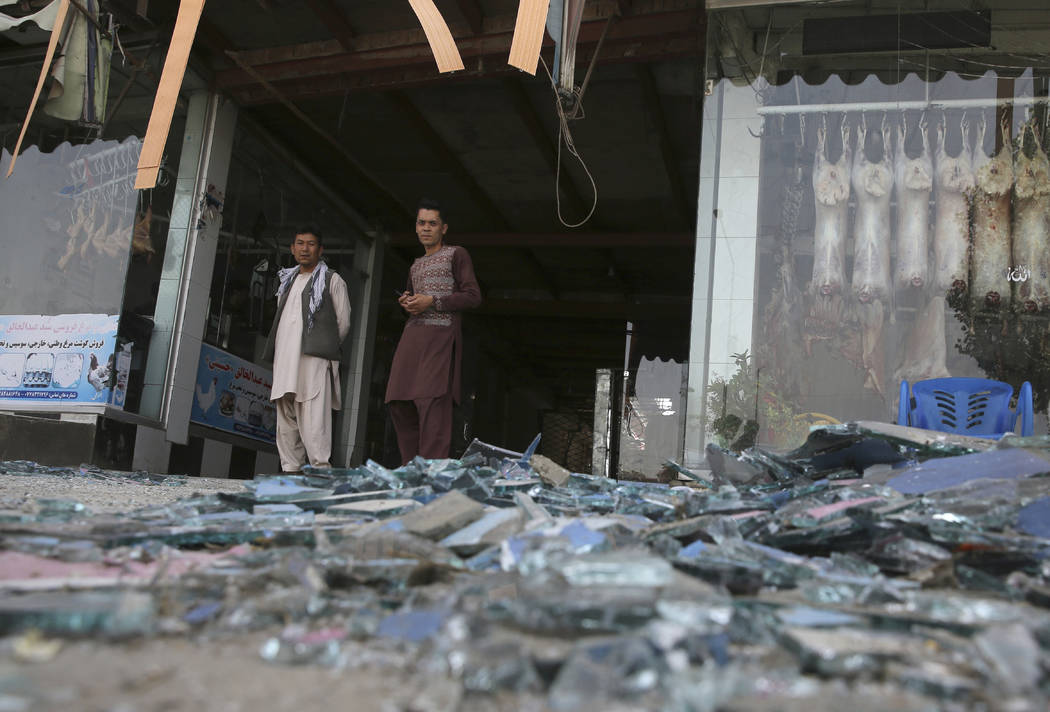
[1011,124,1050,312]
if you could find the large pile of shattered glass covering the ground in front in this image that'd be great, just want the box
[0,422,1050,711]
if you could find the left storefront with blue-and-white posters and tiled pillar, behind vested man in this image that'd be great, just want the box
[0,47,382,477]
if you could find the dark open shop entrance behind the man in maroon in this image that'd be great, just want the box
[197,2,705,477]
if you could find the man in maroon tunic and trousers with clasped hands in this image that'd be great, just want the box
[386,198,481,464]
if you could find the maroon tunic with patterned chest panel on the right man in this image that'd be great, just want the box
[385,245,481,403]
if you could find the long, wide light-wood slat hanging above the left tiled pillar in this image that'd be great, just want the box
[134,0,205,189]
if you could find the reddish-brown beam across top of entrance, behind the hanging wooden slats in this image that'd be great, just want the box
[215,8,702,89]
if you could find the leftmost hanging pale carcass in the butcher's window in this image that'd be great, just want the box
[806,122,852,343]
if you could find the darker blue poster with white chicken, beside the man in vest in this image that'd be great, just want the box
[190,343,277,442]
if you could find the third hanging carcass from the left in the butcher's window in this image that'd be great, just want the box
[894,117,933,292]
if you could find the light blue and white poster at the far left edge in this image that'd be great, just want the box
[0,314,117,409]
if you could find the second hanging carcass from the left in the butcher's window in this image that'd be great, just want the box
[852,114,894,395]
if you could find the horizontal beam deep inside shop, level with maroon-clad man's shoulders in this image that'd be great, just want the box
[390,232,696,249]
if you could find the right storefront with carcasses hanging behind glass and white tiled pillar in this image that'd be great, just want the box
[686,1,1050,463]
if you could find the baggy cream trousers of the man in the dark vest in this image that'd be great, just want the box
[273,383,332,473]
